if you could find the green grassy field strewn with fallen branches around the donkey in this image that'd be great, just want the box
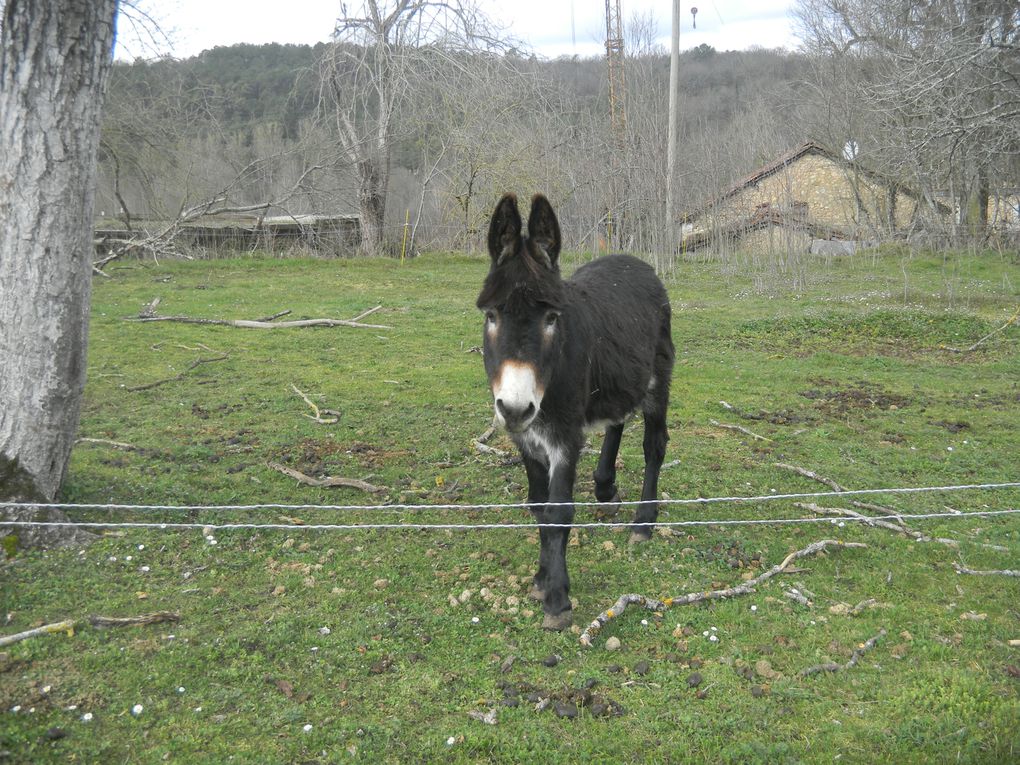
[0,252,1020,763]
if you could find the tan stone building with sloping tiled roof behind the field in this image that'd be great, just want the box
[681,142,948,252]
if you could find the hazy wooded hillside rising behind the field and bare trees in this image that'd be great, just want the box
[98,44,807,248]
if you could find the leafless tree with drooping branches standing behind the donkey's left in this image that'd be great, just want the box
[320,0,502,254]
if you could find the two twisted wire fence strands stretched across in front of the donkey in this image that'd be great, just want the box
[0,481,1020,531]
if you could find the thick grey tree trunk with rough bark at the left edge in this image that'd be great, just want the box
[0,0,117,543]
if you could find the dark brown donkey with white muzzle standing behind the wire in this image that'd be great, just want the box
[477,194,674,630]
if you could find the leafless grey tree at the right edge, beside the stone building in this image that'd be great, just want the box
[798,0,1020,241]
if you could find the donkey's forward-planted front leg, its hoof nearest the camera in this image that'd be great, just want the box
[539,457,576,630]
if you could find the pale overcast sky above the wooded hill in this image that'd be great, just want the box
[117,0,798,59]
